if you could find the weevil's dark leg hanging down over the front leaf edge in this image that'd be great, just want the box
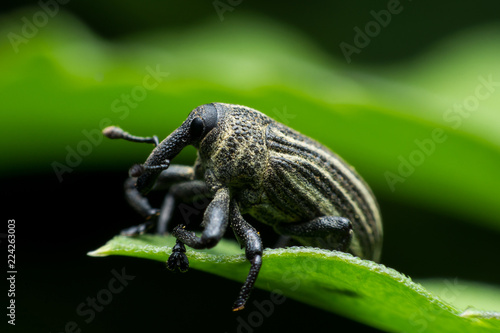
[231,201,263,311]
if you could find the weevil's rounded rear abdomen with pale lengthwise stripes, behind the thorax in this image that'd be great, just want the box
[264,123,382,260]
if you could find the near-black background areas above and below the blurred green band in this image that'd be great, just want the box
[0,0,500,332]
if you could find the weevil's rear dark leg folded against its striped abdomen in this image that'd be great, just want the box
[275,216,353,252]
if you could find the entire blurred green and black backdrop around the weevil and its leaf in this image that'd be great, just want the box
[0,1,500,332]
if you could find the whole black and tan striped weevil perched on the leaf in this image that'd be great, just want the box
[103,103,382,311]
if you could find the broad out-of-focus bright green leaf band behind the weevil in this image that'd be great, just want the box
[0,11,500,230]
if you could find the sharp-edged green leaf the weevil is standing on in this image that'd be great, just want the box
[89,235,500,333]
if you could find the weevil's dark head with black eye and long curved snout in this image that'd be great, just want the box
[133,104,219,194]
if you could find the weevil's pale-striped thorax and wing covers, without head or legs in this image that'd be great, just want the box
[196,103,382,260]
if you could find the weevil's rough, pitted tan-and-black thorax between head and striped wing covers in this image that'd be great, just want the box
[200,108,268,188]
